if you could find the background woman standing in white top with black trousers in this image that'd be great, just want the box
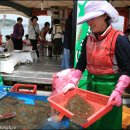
[28,16,40,57]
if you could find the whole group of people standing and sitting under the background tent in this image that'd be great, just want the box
[1,13,72,69]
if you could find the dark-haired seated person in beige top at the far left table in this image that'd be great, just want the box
[5,35,14,52]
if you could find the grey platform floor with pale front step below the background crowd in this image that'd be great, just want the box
[2,57,61,84]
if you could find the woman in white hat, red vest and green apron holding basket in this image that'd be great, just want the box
[62,1,130,130]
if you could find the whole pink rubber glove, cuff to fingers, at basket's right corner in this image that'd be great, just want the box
[108,75,130,106]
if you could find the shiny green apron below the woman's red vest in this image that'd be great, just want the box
[87,74,122,130]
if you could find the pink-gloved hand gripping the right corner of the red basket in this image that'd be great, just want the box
[108,90,122,107]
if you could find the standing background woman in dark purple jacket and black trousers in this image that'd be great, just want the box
[12,17,24,50]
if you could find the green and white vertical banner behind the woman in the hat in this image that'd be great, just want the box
[75,0,90,89]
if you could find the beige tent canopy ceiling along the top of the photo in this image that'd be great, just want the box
[0,0,130,16]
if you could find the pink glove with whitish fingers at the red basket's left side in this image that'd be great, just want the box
[62,69,82,93]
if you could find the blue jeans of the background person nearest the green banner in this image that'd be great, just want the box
[61,48,70,69]
